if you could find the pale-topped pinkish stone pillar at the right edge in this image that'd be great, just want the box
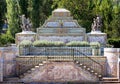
[104,48,119,78]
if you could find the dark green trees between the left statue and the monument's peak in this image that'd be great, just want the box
[28,0,52,31]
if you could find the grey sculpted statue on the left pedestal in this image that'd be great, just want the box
[21,15,32,31]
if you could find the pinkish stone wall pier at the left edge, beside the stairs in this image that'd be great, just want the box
[0,46,18,77]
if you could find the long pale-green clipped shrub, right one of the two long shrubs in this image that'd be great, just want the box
[66,41,89,47]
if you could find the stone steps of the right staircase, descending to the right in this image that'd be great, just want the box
[75,61,102,80]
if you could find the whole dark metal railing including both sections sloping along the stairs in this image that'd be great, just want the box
[17,47,103,75]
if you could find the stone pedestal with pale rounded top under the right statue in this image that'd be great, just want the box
[87,31,107,45]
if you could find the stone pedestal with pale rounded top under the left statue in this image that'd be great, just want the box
[15,31,36,45]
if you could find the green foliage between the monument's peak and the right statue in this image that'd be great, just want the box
[53,0,94,32]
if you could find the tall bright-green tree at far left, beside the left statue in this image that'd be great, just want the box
[6,0,20,36]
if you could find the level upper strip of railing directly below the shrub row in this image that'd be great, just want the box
[19,46,92,56]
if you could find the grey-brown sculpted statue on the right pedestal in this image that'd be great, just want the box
[91,16,102,32]
